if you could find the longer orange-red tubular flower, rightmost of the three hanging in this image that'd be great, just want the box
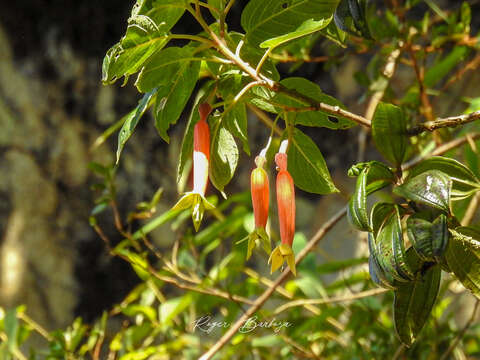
[269,153,296,275]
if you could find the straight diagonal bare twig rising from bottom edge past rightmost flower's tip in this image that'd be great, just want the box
[200,208,347,360]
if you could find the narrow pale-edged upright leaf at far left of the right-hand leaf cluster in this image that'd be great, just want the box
[347,169,372,231]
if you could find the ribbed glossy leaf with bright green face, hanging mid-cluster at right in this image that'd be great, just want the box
[375,205,413,281]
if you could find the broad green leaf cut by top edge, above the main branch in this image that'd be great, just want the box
[241,0,338,45]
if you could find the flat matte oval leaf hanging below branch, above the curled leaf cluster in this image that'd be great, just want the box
[372,103,408,166]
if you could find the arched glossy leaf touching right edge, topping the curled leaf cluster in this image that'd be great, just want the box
[407,156,480,198]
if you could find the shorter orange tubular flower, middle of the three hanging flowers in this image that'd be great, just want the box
[247,155,271,260]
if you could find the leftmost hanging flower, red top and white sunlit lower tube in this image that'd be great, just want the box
[173,103,215,231]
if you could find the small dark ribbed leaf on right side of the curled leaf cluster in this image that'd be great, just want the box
[407,214,434,261]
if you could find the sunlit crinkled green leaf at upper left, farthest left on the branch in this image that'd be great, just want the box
[102,0,185,83]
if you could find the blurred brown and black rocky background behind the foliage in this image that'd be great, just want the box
[0,0,476,330]
